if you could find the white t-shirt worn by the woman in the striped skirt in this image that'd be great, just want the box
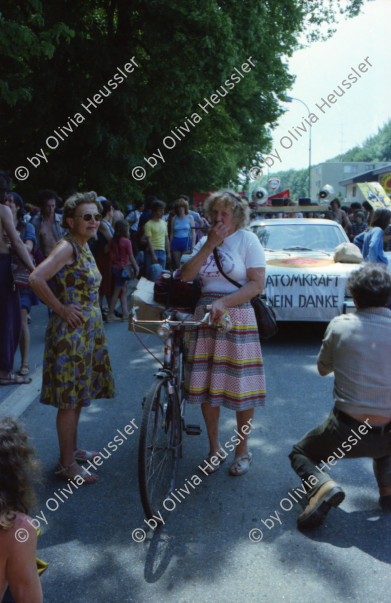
[190,230,266,293]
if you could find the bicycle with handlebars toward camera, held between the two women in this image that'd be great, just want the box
[130,308,213,520]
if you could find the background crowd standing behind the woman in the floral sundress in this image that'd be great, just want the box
[0,179,208,392]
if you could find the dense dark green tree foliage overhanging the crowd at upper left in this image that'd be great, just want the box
[0,0,363,203]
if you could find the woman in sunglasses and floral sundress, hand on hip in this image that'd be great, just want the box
[30,192,114,485]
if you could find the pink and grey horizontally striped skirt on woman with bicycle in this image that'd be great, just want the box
[185,293,266,411]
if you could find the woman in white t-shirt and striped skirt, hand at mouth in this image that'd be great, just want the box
[181,190,266,475]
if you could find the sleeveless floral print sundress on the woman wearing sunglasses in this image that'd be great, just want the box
[40,235,114,410]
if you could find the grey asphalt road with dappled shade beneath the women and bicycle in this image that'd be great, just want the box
[0,307,391,603]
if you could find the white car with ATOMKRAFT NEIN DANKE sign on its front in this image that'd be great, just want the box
[250,218,360,322]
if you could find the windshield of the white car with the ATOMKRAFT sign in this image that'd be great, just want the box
[251,220,347,252]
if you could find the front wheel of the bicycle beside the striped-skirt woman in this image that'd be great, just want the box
[138,377,182,519]
